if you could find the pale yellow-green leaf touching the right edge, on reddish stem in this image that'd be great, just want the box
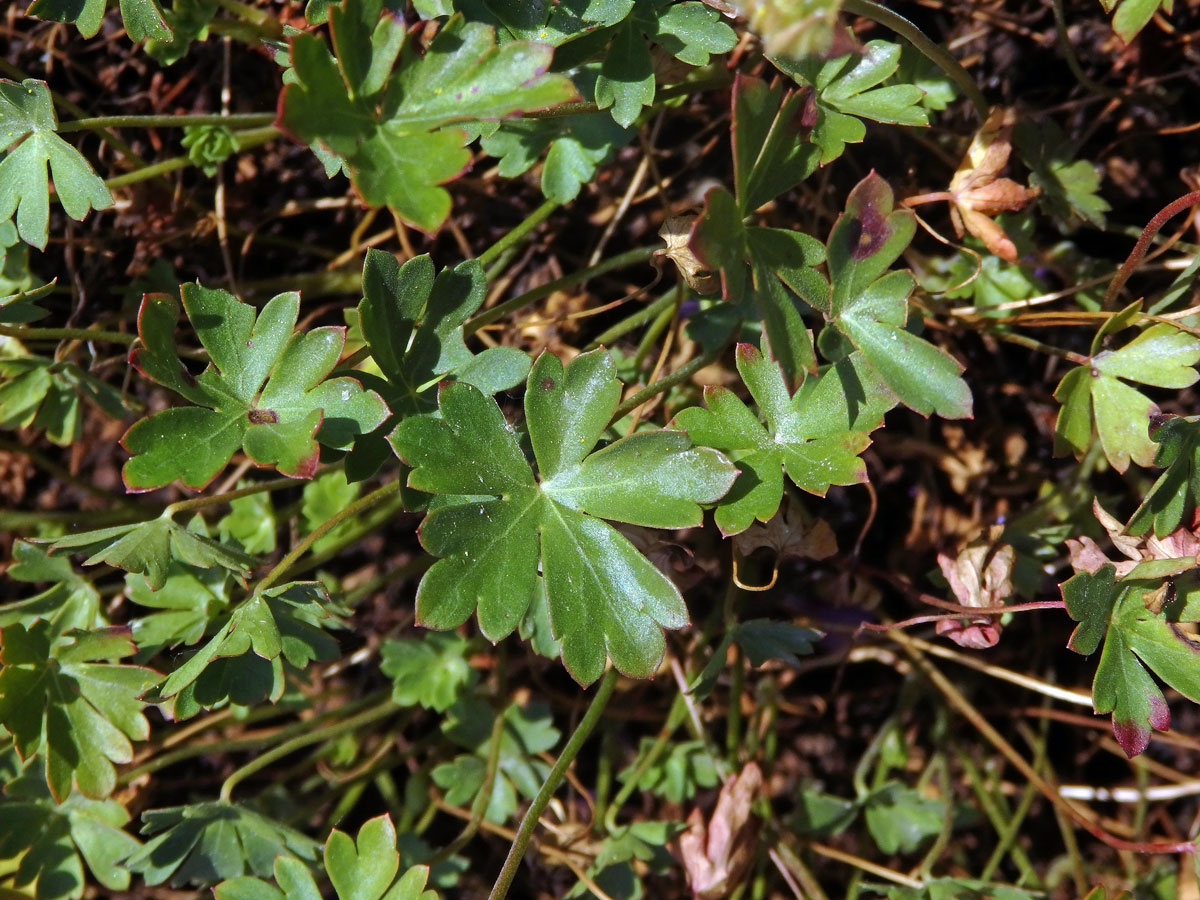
[1054,323,1200,472]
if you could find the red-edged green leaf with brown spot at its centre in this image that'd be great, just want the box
[121,284,388,491]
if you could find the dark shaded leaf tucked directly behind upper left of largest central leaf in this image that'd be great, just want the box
[346,250,529,481]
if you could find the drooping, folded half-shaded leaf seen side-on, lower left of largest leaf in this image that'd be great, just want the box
[160,581,342,707]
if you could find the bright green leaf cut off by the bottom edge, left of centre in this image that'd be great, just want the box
[212,816,438,900]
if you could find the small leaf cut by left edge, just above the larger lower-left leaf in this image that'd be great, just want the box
[0,541,108,635]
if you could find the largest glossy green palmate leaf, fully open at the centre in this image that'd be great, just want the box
[391,350,736,684]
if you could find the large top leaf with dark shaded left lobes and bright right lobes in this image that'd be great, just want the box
[278,0,577,232]
